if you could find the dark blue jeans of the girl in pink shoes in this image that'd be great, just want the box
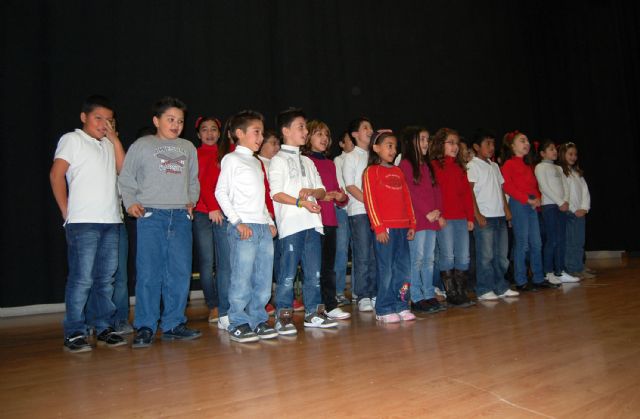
[373,228,411,316]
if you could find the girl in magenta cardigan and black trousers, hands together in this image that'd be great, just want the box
[304,121,351,320]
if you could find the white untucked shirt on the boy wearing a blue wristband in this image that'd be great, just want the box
[268,144,324,239]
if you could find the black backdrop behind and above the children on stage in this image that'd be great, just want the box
[0,0,640,307]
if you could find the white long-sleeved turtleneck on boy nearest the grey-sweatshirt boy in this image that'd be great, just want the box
[216,146,274,225]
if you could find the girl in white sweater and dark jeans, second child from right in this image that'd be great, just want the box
[535,141,580,284]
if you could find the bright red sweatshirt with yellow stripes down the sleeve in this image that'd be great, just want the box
[362,164,416,234]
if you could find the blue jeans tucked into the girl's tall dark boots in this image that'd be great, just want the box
[438,220,469,271]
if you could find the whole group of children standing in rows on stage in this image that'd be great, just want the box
[51,96,589,352]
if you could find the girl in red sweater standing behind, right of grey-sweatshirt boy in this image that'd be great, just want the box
[193,116,231,323]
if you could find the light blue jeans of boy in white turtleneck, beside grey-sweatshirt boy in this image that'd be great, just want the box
[227,224,273,330]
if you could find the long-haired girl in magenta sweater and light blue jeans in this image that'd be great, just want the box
[399,127,445,313]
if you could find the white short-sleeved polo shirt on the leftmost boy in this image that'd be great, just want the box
[54,129,122,224]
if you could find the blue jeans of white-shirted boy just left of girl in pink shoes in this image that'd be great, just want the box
[349,214,377,300]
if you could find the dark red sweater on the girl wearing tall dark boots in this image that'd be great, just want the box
[431,156,473,222]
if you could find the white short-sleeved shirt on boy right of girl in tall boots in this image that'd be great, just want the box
[467,157,504,217]
